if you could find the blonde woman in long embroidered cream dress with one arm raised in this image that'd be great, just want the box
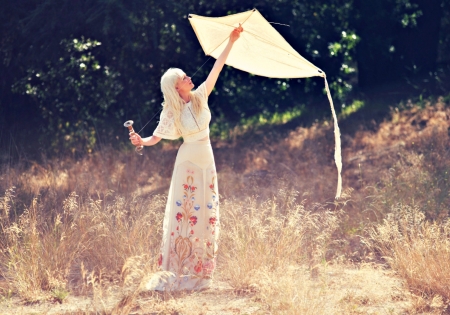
[130,26,243,290]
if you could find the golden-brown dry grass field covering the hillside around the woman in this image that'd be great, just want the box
[0,101,450,314]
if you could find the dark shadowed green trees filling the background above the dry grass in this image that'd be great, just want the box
[0,0,450,157]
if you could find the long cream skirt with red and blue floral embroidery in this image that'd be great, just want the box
[146,140,219,291]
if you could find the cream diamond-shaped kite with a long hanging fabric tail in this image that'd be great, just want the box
[189,9,342,199]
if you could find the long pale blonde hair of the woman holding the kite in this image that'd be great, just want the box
[161,68,202,130]
